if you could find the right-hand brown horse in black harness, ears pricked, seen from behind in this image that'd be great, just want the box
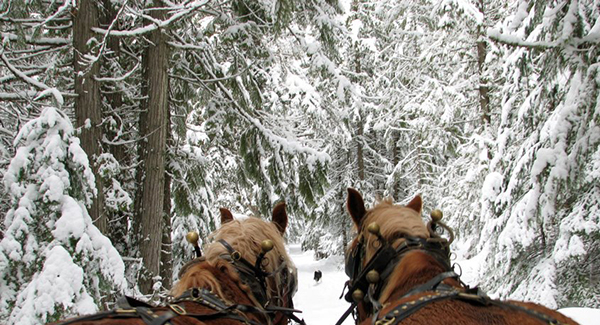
[338,189,576,325]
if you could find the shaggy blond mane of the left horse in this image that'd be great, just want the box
[171,217,295,304]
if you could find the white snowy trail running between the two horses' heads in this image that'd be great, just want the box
[288,244,354,325]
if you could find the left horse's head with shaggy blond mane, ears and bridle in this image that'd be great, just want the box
[171,203,297,316]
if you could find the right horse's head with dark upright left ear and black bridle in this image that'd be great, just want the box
[346,189,450,319]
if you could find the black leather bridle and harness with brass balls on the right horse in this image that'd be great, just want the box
[336,220,562,325]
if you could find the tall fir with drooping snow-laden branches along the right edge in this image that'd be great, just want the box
[438,1,600,308]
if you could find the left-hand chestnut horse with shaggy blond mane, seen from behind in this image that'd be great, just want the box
[58,203,304,325]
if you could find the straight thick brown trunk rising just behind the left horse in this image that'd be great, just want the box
[136,3,169,293]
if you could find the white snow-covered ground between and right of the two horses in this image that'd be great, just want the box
[288,244,600,325]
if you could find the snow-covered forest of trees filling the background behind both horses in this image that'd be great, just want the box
[0,0,600,324]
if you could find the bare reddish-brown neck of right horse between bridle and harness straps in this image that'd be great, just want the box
[379,251,458,304]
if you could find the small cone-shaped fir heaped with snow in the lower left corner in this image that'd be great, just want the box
[0,107,126,325]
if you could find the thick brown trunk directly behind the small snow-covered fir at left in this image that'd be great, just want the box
[73,0,108,234]
